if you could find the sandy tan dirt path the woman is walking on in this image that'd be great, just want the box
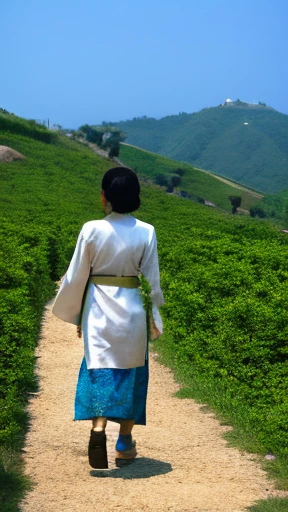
[21,306,273,512]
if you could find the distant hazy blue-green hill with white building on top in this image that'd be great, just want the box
[116,101,288,193]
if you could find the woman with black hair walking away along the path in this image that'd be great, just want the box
[53,167,163,469]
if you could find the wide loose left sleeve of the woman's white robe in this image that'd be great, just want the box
[52,228,91,325]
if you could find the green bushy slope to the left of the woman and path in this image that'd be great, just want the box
[0,129,109,512]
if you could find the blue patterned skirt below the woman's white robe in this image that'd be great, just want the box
[74,358,149,425]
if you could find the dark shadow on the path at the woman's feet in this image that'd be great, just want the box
[90,457,172,480]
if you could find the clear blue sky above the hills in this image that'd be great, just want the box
[0,0,288,128]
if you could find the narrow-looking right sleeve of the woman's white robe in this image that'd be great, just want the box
[140,228,164,333]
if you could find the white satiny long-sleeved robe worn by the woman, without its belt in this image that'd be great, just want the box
[52,212,164,369]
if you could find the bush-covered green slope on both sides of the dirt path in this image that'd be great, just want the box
[0,111,288,512]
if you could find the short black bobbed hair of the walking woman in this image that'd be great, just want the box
[102,167,140,213]
